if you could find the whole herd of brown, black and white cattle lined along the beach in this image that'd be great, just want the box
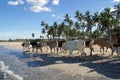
[22,38,120,56]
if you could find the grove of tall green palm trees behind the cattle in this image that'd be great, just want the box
[41,3,120,39]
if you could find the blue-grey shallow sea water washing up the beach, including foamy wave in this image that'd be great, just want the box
[0,46,111,80]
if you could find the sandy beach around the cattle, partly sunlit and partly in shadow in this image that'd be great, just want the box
[0,42,120,80]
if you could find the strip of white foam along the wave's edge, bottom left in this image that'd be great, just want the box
[0,61,23,80]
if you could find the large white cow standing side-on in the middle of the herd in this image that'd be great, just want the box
[62,40,86,56]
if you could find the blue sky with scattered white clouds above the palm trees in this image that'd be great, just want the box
[0,0,120,40]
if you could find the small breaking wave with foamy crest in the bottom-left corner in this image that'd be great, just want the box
[0,61,23,80]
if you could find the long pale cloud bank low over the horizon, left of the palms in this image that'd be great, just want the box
[0,31,43,40]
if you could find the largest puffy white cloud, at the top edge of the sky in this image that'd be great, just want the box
[27,0,51,12]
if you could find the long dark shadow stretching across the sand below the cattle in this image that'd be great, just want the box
[26,54,120,79]
